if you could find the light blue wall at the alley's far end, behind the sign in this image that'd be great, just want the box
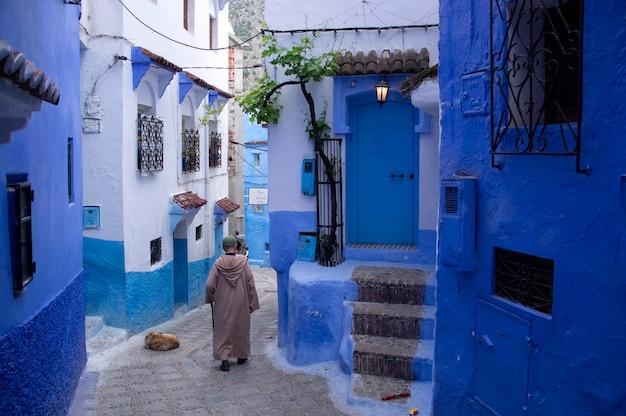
[243,115,270,267]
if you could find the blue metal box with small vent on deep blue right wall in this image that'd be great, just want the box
[439,176,476,272]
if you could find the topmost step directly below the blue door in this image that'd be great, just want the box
[351,266,436,305]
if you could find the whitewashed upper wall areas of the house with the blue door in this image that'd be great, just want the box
[265,0,439,218]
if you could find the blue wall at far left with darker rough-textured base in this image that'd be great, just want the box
[0,0,87,415]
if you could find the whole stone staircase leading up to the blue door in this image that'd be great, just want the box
[351,266,435,414]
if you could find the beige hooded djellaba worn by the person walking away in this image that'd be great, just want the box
[206,254,260,361]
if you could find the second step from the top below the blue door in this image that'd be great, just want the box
[352,302,435,339]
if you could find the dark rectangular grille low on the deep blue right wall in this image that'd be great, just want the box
[493,247,554,314]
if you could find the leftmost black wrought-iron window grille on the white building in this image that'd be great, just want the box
[137,114,163,172]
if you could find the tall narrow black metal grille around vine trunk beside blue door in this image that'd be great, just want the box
[316,139,343,267]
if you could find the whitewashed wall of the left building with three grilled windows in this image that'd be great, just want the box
[81,0,229,271]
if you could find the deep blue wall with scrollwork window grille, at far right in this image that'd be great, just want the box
[434,0,626,415]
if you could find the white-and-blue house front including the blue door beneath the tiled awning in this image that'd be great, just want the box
[265,0,439,358]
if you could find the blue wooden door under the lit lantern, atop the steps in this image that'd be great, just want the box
[348,102,418,245]
